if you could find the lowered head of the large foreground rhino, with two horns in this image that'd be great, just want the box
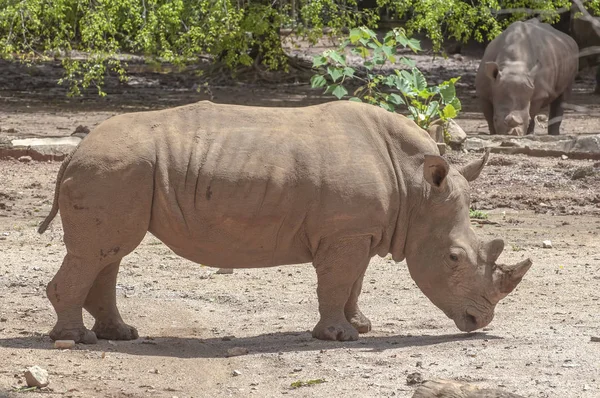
[405,153,531,332]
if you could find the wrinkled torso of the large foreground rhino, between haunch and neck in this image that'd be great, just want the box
[101,102,414,266]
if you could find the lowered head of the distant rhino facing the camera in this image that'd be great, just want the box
[485,62,539,135]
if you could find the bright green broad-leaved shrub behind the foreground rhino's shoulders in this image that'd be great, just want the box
[311,27,461,128]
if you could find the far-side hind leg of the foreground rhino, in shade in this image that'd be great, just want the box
[84,260,138,340]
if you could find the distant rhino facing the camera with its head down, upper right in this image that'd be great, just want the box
[475,19,579,135]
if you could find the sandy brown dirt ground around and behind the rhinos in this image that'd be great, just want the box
[0,38,600,398]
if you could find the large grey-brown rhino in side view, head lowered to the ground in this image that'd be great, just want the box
[38,101,531,343]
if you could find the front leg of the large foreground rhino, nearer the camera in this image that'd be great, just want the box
[313,236,371,341]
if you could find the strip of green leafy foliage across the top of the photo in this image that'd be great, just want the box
[0,0,600,94]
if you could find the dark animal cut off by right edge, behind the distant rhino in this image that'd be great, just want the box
[570,4,600,94]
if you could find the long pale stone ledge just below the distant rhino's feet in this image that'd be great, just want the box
[464,134,600,160]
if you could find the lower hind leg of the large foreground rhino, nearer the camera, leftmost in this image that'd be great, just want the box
[46,254,97,344]
